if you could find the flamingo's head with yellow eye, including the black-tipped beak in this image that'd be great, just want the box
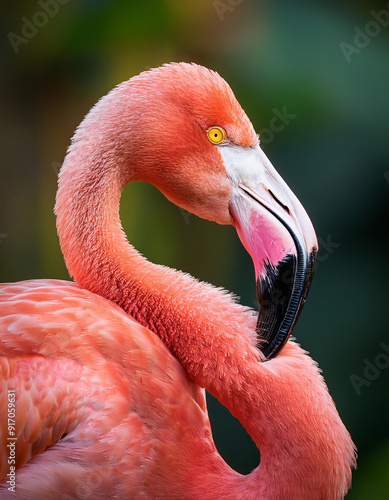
[96,63,318,359]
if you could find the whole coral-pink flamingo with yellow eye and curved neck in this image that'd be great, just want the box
[0,63,355,500]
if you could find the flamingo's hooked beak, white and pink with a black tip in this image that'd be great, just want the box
[219,144,318,359]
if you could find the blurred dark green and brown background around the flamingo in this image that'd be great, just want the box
[0,0,389,500]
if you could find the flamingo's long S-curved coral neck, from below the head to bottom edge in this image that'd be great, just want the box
[56,124,352,500]
